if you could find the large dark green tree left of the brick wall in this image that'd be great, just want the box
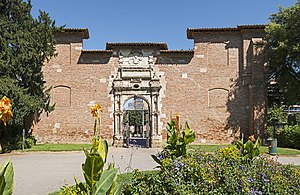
[0,0,58,142]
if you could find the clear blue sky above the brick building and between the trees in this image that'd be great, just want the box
[31,0,296,49]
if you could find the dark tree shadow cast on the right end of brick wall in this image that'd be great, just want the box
[226,40,267,142]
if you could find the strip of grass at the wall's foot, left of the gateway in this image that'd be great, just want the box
[24,144,91,152]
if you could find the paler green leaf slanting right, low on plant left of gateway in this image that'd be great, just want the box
[95,168,118,195]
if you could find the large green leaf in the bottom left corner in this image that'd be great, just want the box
[0,159,14,195]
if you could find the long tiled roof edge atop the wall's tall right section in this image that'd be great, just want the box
[187,24,266,39]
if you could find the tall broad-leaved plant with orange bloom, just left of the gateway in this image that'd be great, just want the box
[62,103,121,195]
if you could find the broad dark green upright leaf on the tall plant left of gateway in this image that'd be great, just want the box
[82,153,104,189]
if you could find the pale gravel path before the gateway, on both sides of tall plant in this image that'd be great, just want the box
[0,148,158,195]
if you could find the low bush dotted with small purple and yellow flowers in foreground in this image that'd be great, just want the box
[123,146,300,195]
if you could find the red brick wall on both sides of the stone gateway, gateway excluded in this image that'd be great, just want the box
[33,31,265,143]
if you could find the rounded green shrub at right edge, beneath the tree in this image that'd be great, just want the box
[278,125,300,149]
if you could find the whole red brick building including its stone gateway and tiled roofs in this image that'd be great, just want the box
[33,25,266,147]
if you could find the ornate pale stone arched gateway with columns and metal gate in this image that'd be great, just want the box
[112,48,162,147]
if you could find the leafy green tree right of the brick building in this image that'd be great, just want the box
[266,0,300,104]
